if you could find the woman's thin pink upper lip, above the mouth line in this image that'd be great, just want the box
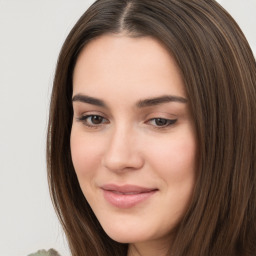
[101,184,157,193]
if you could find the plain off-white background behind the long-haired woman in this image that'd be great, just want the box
[0,0,256,256]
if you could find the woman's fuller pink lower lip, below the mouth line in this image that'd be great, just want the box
[103,190,157,209]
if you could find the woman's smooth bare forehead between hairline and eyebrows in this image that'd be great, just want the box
[73,34,185,102]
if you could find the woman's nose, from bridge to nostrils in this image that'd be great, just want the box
[102,127,144,172]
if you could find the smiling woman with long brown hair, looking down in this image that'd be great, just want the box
[47,0,256,256]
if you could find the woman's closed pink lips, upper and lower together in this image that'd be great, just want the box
[101,184,158,209]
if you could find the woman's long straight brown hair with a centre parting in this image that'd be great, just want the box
[47,0,256,256]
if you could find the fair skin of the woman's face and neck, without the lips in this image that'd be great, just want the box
[70,34,196,256]
